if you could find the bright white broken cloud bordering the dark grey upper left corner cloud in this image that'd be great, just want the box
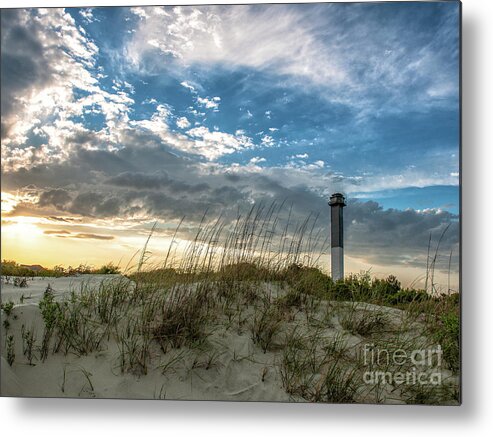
[2,8,134,169]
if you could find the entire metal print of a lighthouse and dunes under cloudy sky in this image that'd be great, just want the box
[1,1,461,405]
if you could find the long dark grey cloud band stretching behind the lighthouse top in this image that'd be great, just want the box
[3,139,459,267]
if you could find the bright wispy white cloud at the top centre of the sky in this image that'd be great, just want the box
[125,5,345,87]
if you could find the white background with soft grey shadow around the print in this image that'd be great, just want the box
[0,0,493,437]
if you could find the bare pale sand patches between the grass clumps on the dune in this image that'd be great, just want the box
[0,275,460,403]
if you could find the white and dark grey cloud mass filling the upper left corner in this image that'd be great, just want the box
[1,8,134,169]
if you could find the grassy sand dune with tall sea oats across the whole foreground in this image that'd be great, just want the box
[2,205,460,404]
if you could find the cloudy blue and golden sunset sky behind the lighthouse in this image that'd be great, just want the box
[1,2,460,288]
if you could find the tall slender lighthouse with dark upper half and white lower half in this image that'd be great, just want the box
[329,193,346,281]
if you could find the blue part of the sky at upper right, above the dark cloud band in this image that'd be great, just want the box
[68,3,459,209]
